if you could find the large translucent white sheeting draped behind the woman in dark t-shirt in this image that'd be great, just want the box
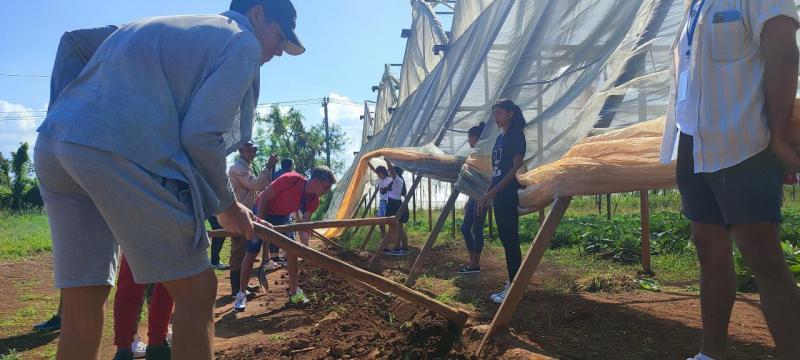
[328,0,684,224]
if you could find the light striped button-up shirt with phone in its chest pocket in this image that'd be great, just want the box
[661,0,800,173]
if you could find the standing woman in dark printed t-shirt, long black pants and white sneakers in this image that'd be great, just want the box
[478,99,525,303]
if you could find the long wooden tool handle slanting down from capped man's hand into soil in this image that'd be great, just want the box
[254,224,468,329]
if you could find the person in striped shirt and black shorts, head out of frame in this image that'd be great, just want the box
[661,0,800,359]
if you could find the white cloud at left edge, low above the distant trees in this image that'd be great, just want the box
[0,100,47,158]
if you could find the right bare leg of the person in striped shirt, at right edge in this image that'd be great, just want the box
[731,222,800,359]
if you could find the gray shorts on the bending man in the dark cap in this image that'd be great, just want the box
[34,135,210,288]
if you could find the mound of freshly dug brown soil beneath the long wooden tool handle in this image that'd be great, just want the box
[217,268,456,359]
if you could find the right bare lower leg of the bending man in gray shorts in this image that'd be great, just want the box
[162,268,216,360]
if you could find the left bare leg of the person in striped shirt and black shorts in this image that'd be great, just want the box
[692,222,736,359]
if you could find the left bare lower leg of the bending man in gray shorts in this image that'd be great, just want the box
[56,285,111,360]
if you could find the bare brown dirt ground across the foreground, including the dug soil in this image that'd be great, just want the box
[0,242,773,359]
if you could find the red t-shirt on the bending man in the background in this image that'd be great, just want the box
[258,171,319,215]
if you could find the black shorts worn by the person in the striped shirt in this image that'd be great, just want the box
[676,133,783,225]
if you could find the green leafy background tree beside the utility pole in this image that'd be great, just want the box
[253,106,347,174]
